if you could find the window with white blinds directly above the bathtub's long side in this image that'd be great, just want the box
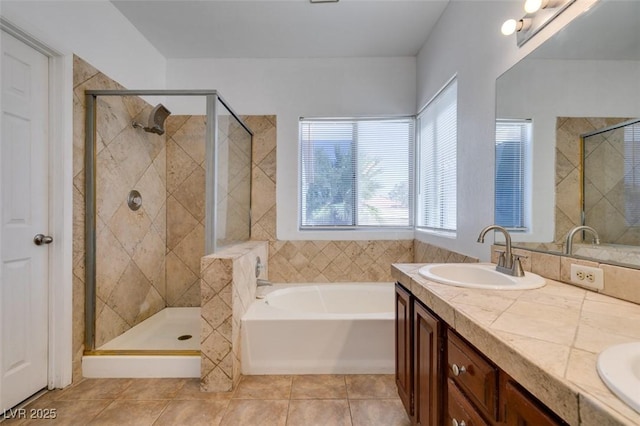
[299,118,414,229]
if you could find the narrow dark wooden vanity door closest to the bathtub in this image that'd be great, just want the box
[395,283,413,417]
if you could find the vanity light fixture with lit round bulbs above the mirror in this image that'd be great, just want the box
[501,0,576,46]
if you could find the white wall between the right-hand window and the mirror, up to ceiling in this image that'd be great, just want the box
[416,0,593,260]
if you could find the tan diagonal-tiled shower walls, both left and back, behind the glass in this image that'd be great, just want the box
[73,57,204,380]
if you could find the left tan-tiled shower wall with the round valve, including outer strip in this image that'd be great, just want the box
[72,57,172,380]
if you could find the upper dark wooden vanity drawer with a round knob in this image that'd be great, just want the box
[447,330,498,420]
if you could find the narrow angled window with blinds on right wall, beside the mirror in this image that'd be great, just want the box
[417,79,458,232]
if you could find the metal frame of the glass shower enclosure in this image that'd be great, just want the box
[84,89,253,355]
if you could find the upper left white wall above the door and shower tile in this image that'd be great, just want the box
[0,0,166,89]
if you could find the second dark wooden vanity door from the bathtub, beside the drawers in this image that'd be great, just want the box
[413,301,442,426]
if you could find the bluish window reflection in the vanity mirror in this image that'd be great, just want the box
[495,120,531,231]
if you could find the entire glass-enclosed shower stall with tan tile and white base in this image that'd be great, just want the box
[83,90,252,377]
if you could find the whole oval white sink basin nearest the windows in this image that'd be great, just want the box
[418,263,546,290]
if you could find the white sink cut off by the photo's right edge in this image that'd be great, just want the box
[596,342,640,413]
